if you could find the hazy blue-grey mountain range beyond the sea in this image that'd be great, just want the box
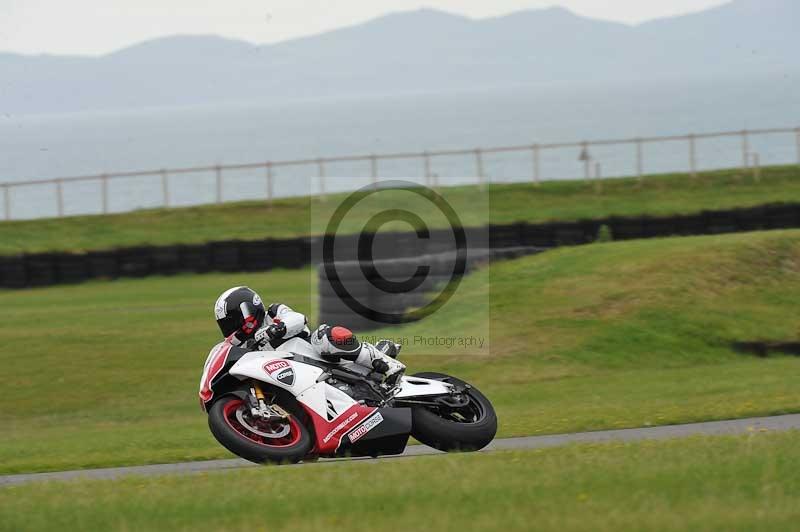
[0,0,800,114]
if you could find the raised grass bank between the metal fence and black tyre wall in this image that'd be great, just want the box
[0,166,800,255]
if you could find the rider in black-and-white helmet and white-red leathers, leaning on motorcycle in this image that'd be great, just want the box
[214,286,406,384]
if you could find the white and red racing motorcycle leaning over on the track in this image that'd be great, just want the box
[199,338,497,463]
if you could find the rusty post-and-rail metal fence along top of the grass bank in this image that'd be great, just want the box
[0,127,800,220]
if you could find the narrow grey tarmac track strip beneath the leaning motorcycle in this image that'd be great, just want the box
[0,414,800,487]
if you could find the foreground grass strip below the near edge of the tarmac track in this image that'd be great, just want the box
[0,432,800,532]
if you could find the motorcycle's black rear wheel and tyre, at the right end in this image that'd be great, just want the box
[411,373,497,451]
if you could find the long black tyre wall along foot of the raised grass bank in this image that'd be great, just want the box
[0,203,800,288]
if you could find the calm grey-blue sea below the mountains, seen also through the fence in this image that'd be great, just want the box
[0,72,800,220]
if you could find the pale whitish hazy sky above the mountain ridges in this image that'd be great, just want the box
[0,0,726,55]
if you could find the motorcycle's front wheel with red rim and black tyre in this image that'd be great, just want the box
[208,395,313,464]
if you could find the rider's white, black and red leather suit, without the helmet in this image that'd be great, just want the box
[255,304,406,382]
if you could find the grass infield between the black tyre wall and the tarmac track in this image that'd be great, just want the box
[0,231,800,473]
